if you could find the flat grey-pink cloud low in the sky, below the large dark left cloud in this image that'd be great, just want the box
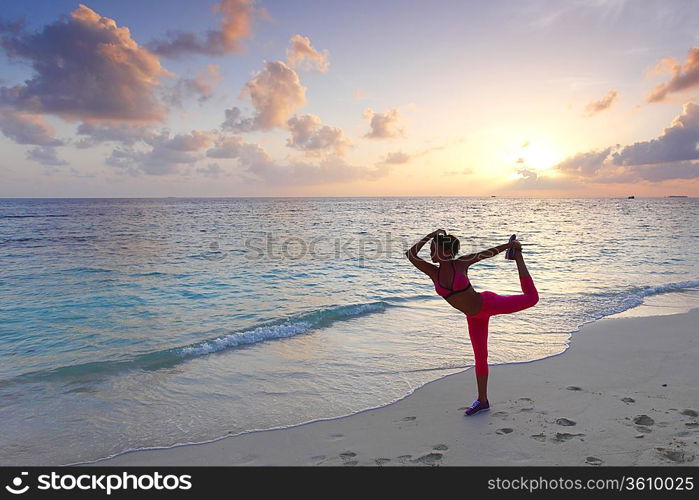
[106,130,213,175]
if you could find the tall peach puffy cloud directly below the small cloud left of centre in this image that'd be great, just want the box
[221,61,306,132]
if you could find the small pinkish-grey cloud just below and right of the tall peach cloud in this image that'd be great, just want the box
[286,115,351,155]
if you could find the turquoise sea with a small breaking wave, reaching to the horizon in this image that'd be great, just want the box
[0,198,699,465]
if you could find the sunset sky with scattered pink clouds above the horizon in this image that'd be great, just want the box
[0,0,699,197]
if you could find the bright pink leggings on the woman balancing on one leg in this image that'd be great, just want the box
[466,276,539,376]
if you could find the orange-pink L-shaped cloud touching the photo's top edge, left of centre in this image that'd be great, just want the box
[147,0,266,57]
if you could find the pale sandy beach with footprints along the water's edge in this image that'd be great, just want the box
[95,308,699,466]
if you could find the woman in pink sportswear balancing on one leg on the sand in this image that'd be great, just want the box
[406,229,539,416]
